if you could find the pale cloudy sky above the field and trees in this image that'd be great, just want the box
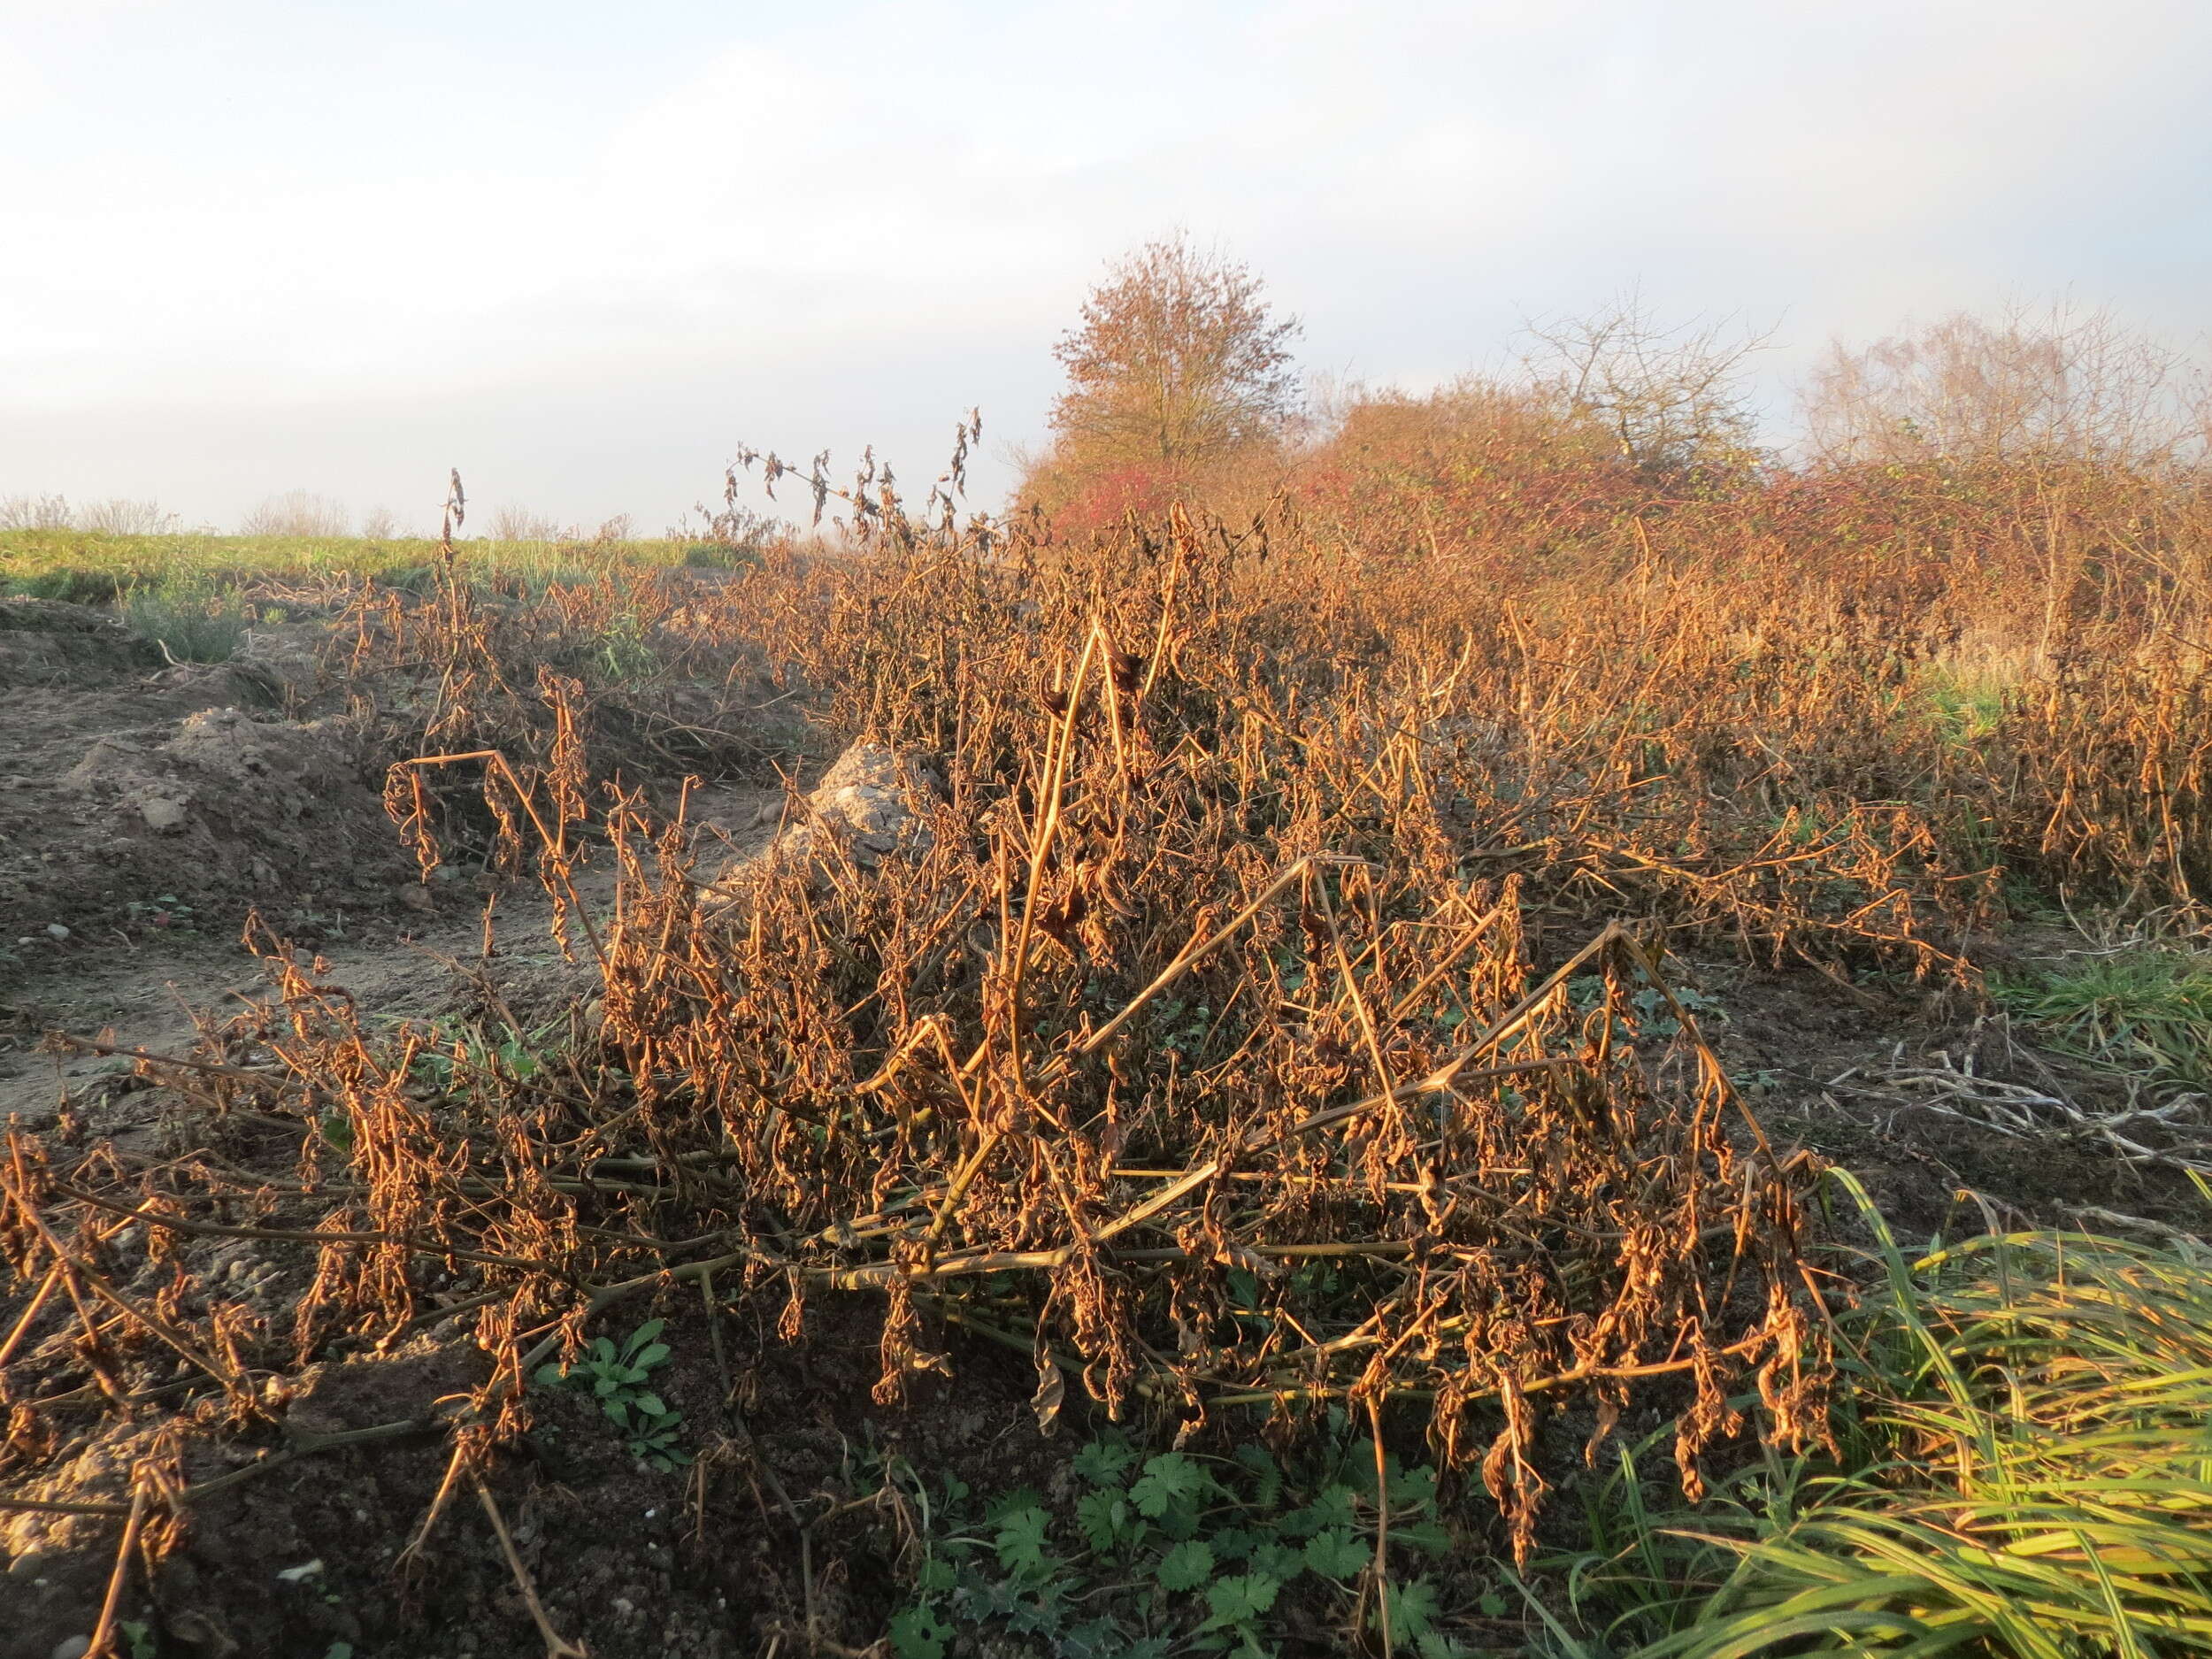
[0,0,2212,531]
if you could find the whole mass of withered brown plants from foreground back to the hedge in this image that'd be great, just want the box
[0,442,2206,1644]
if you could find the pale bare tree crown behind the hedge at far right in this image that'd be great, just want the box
[1803,303,2206,465]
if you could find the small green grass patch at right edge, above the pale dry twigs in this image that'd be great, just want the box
[1991,949,2212,1088]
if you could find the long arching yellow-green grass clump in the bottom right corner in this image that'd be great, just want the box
[1531,1177,2212,1659]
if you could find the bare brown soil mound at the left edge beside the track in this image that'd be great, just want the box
[0,600,411,1000]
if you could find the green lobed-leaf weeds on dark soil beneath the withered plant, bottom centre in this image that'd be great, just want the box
[887,1423,1463,1659]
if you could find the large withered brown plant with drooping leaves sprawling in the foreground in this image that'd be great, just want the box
[4,497,1832,1646]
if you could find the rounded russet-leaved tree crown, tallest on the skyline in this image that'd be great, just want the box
[1053,233,1299,472]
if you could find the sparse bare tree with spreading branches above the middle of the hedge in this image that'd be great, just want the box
[1525,290,1770,473]
